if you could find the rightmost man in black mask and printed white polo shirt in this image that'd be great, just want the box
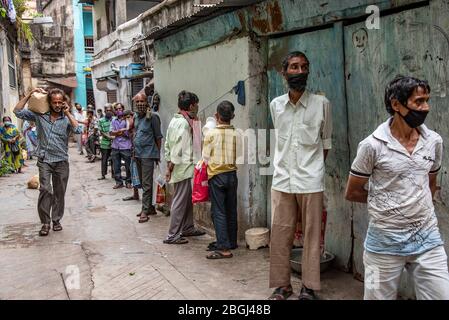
[346,76,449,300]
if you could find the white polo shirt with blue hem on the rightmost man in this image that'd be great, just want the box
[351,118,443,256]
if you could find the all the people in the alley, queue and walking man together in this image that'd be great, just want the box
[6,51,449,300]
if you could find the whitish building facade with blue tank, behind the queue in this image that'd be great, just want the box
[90,0,157,109]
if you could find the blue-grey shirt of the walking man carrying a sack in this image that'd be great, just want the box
[14,109,82,163]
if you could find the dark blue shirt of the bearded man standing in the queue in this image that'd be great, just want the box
[134,113,163,159]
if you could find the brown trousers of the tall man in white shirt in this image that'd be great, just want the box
[270,190,323,290]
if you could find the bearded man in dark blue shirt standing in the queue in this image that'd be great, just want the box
[133,93,162,223]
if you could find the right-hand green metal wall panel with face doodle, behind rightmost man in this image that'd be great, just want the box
[344,1,449,282]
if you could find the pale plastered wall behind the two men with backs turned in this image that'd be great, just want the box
[155,37,266,236]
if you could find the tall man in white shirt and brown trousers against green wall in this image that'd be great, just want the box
[269,51,332,300]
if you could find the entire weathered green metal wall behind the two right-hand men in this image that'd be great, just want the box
[268,1,449,290]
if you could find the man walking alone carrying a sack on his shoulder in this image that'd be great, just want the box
[14,88,81,236]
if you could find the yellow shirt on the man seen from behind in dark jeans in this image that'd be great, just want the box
[203,125,238,179]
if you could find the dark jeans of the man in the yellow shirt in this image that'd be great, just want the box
[209,171,238,250]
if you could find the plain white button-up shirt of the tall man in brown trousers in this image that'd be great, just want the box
[270,91,332,194]
